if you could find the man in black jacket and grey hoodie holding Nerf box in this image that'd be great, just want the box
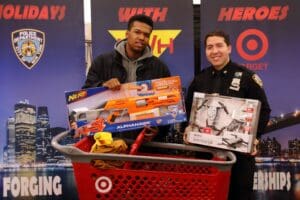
[83,15,170,90]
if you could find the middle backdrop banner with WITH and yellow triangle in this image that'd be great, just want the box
[91,0,194,90]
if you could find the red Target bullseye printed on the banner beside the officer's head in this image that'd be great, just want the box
[236,29,269,61]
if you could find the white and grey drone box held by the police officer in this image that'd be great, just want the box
[187,92,261,153]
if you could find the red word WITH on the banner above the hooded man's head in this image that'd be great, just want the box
[118,7,168,22]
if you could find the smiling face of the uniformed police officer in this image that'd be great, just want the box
[205,36,231,70]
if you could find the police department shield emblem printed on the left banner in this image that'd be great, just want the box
[11,29,45,69]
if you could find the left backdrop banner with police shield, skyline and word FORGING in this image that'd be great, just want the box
[0,0,85,199]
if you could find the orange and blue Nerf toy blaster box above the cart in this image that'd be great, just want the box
[65,76,187,134]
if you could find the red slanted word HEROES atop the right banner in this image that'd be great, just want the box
[218,5,289,21]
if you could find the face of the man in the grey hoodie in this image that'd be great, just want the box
[126,21,152,53]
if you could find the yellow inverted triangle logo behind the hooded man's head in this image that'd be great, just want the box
[108,30,181,57]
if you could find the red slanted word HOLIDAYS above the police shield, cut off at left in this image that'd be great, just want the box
[0,4,66,21]
